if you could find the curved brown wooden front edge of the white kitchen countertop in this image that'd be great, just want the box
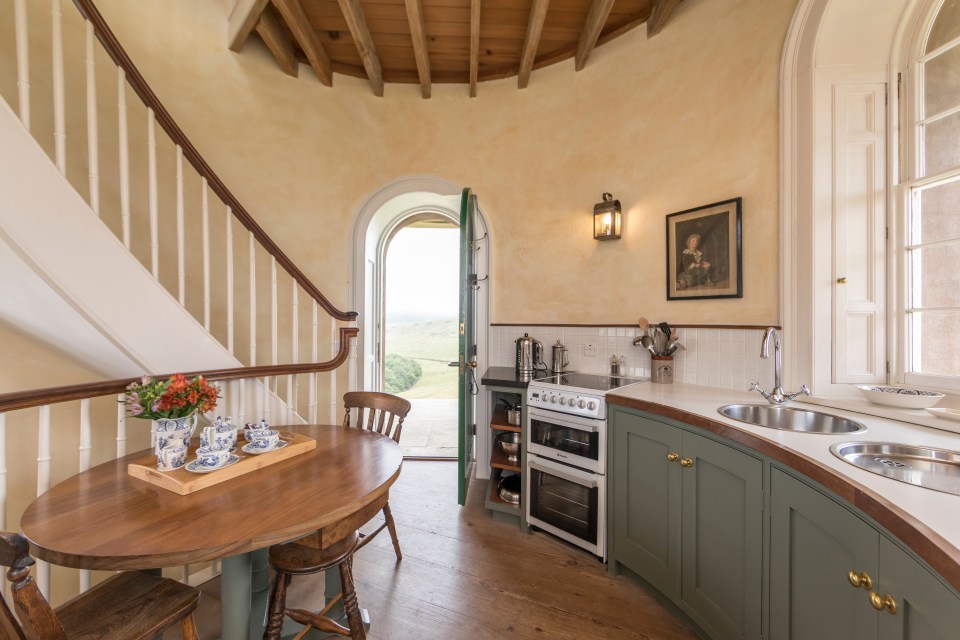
[607,393,960,591]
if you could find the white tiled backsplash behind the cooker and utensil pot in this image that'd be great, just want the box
[490,326,773,390]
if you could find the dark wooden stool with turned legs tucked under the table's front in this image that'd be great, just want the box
[263,531,367,640]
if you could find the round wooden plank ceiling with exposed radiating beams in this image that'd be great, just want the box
[228,0,683,98]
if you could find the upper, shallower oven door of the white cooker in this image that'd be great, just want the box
[527,408,607,473]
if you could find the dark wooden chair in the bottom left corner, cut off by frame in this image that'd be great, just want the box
[0,532,200,640]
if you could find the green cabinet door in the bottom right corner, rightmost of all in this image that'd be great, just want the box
[875,537,960,640]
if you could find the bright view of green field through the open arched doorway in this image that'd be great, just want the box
[382,217,460,458]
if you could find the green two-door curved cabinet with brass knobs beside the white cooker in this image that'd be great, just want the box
[608,408,763,639]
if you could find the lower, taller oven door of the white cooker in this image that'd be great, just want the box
[524,456,606,562]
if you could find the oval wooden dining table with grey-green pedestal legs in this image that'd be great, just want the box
[20,425,403,640]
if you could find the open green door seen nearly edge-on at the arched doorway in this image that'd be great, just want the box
[457,188,477,505]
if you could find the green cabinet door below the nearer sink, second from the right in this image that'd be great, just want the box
[770,469,880,640]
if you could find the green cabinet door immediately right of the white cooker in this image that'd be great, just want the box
[612,413,683,597]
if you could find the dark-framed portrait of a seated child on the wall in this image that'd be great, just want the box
[667,198,743,300]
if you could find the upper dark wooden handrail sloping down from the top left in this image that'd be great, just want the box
[73,0,358,321]
